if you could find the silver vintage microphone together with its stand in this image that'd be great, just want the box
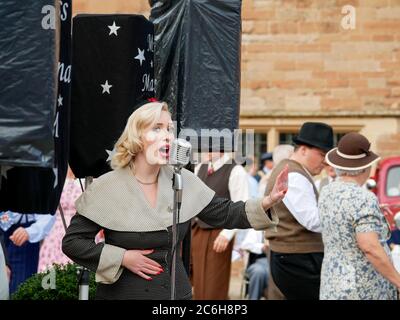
[169,139,192,300]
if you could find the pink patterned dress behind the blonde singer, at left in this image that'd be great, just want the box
[38,179,82,272]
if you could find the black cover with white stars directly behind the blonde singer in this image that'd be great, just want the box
[70,14,154,178]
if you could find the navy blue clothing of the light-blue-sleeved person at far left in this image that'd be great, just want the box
[4,222,40,294]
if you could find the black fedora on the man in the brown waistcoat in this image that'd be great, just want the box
[293,122,333,152]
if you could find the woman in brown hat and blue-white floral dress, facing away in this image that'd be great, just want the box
[319,132,400,300]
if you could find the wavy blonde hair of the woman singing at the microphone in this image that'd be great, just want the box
[111,102,168,170]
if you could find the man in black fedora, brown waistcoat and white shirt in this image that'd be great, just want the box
[265,122,333,300]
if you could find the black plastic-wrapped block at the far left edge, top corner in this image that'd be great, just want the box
[0,0,59,167]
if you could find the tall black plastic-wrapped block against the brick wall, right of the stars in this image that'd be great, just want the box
[150,0,241,151]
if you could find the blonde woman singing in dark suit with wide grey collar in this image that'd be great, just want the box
[62,102,288,300]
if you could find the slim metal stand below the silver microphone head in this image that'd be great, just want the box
[171,166,183,300]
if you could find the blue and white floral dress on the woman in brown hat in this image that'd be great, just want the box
[319,180,397,300]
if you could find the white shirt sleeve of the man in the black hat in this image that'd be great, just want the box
[283,172,322,233]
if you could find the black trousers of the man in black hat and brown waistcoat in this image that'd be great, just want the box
[271,251,324,300]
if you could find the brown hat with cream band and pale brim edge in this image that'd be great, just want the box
[325,132,380,170]
